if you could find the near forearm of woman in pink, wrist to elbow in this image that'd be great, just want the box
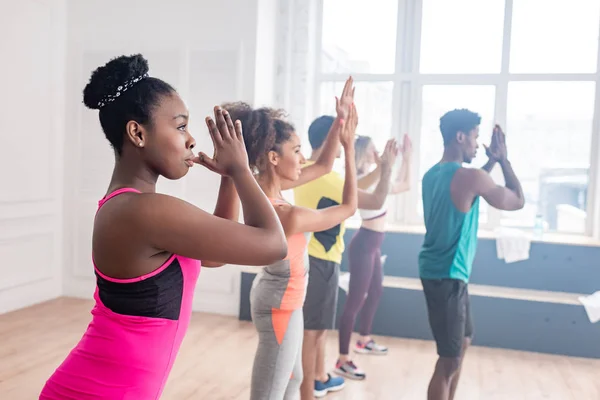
[233,169,281,230]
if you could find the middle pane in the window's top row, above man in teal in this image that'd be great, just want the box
[420,0,508,74]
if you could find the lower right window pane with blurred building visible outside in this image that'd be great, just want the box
[502,82,595,233]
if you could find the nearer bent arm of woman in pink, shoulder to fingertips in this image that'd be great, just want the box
[134,107,287,265]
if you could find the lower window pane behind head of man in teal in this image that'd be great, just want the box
[417,85,496,223]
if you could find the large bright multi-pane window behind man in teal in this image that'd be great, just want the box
[314,0,600,238]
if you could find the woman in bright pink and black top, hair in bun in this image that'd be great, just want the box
[39,55,287,400]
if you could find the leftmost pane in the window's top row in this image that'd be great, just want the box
[321,0,398,74]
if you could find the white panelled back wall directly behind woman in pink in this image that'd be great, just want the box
[64,0,275,315]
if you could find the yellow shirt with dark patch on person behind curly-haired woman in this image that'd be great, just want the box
[294,161,346,264]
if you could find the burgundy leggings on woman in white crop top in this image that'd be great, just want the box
[339,228,385,355]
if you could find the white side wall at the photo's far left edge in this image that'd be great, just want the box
[0,0,66,313]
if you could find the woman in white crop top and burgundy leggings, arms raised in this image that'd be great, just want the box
[335,135,412,380]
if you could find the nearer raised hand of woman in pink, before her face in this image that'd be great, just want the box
[194,106,249,177]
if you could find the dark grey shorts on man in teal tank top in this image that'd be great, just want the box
[421,279,473,358]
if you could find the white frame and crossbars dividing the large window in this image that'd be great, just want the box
[312,0,600,239]
